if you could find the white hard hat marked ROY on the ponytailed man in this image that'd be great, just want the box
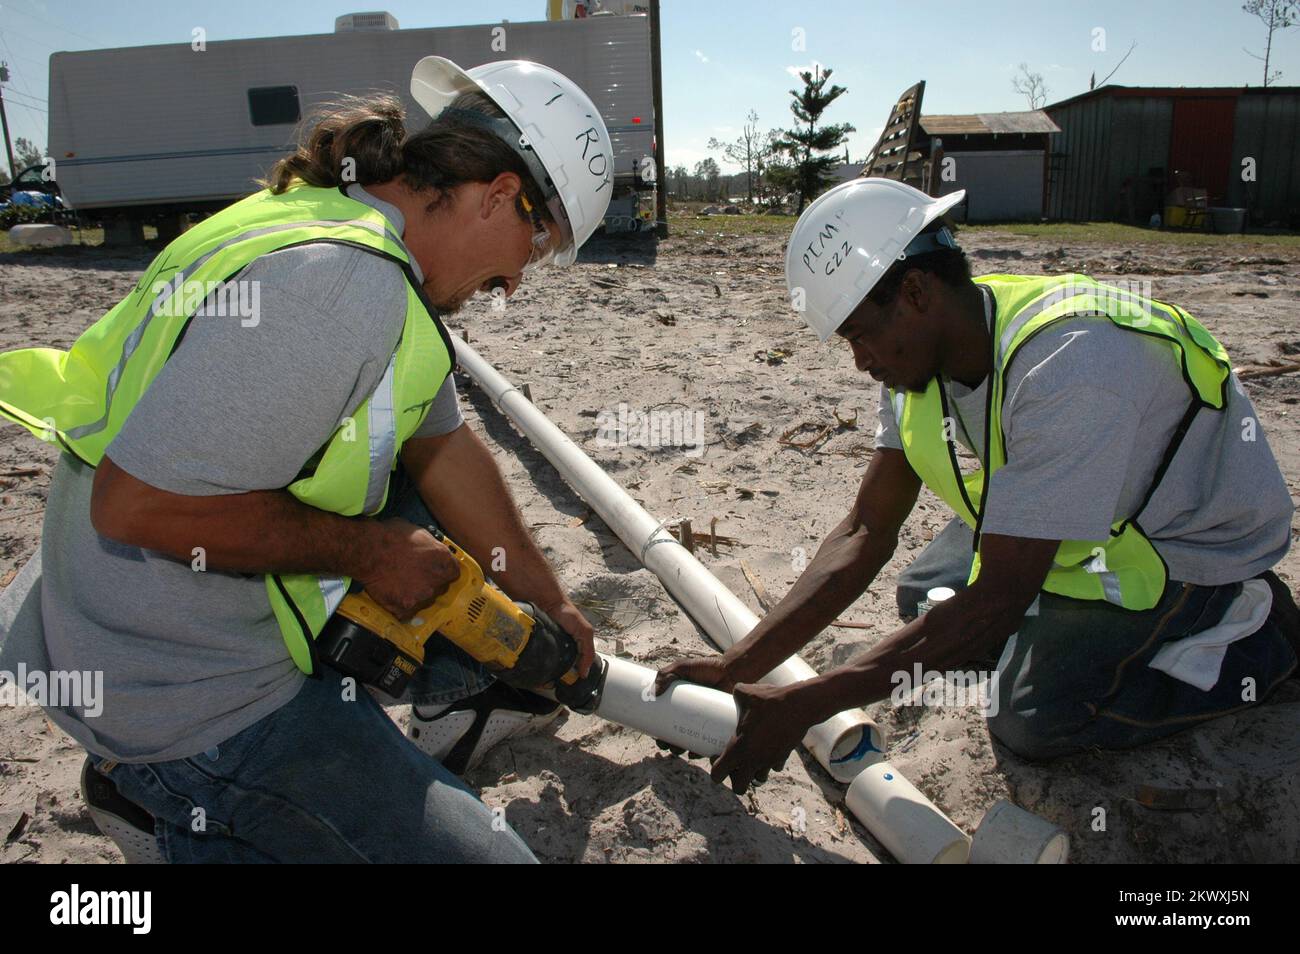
[411,56,614,265]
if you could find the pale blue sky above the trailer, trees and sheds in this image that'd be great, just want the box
[0,0,1300,168]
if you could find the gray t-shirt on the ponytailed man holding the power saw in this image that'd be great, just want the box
[25,186,463,762]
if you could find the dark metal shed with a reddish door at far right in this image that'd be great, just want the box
[1045,86,1300,227]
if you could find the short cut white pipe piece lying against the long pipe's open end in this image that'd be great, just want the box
[844,762,971,864]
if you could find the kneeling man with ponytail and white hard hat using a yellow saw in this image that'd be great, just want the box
[0,57,612,862]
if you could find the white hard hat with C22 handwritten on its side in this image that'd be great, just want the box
[785,178,966,341]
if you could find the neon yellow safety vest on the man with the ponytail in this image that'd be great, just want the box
[0,186,452,673]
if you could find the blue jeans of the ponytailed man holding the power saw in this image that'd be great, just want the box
[92,469,537,863]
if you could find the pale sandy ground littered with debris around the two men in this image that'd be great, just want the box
[0,218,1300,863]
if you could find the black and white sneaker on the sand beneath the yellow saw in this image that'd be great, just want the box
[407,680,562,775]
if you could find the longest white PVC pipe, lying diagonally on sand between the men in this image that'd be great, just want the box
[454,339,885,782]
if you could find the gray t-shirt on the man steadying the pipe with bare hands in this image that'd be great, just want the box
[876,283,1295,586]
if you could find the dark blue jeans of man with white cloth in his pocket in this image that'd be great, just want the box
[898,521,1296,759]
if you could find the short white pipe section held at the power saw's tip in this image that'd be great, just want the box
[595,656,740,756]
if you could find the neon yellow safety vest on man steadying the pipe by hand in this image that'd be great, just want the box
[891,274,1231,610]
